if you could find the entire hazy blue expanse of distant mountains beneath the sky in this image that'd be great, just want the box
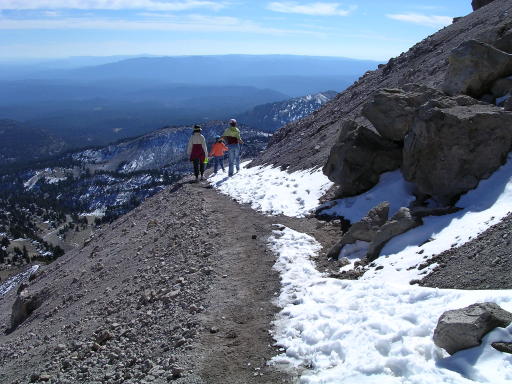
[0,55,377,161]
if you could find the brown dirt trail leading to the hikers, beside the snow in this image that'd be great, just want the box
[180,184,340,384]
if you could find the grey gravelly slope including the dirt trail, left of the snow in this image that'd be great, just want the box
[0,181,340,384]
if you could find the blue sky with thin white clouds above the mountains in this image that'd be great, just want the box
[0,0,471,61]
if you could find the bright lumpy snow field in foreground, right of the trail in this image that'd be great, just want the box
[269,228,512,384]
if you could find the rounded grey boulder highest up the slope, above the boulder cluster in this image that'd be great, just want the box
[443,40,512,97]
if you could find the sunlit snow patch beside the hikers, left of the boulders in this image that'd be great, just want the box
[209,161,333,217]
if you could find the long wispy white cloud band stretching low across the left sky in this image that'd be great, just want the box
[0,14,321,36]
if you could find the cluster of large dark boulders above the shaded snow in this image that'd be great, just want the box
[324,80,512,204]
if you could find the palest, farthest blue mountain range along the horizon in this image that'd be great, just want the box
[10,55,379,97]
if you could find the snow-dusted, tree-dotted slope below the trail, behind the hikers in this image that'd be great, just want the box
[0,121,269,272]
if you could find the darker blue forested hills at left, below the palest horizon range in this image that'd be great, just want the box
[0,80,288,148]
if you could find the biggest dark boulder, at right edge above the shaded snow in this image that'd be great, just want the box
[402,100,512,203]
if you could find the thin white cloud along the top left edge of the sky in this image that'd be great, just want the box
[0,0,225,11]
